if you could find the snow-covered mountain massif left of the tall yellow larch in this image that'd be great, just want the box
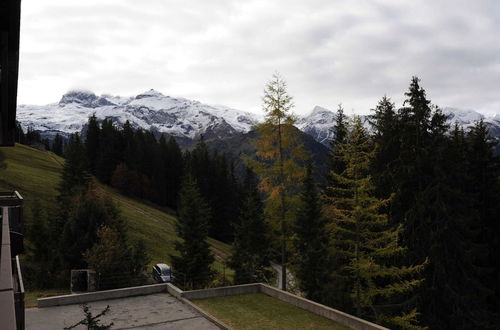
[17,89,259,139]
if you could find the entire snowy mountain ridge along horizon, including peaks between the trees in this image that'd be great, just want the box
[17,89,500,145]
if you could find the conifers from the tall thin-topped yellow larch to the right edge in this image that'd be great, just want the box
[224,77,500,329]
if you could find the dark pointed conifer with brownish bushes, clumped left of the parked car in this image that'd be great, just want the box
[23,135,150,289]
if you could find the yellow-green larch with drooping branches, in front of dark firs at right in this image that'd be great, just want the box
[325,117,423,328]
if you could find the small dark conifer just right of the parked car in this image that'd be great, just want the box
[171,175,214,288]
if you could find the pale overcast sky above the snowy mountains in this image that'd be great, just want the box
[18,0,500,114]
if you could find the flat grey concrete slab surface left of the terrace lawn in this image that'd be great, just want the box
[26,293,219,330]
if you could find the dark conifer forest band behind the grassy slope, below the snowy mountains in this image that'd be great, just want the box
[84,116,240,242]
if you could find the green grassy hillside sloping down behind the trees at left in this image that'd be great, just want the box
[0,144,230,269]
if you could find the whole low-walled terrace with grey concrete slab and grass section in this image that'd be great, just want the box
[26,283,387,330]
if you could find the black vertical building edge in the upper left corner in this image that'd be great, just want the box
[0,0,21,146]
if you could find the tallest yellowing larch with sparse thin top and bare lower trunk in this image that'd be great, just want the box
[247,75,307,290]
